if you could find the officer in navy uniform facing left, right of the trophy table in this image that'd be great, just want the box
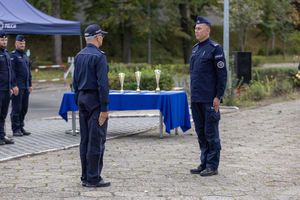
[190,16,227,176]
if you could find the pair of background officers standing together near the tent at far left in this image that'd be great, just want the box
[0,30,32,145]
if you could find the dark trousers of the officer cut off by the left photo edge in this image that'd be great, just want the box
[0,91,10,139]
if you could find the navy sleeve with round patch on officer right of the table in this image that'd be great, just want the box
[214,45,227,96]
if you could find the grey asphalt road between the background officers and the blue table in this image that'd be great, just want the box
[6,88,70,123]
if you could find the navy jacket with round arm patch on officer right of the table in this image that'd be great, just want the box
[190,38,227,103]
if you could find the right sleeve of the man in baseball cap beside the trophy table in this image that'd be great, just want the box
[96,54,109,112]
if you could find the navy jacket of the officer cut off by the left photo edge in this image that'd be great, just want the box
[0,48,16,94]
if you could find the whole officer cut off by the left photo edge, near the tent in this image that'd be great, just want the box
[0,30,19,145]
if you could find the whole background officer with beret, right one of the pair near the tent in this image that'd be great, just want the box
[9,35,32,136]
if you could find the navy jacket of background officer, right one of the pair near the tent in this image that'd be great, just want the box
[9,49,32,89]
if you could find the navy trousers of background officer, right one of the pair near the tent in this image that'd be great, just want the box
[10,89,29,133]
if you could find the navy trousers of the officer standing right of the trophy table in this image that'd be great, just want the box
[191,102,221,170]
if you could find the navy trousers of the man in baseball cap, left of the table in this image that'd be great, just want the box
[78,91,108,184]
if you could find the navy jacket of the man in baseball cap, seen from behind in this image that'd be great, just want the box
[73,44,109,112]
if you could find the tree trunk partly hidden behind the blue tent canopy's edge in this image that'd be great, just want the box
[52,0,62,65]
